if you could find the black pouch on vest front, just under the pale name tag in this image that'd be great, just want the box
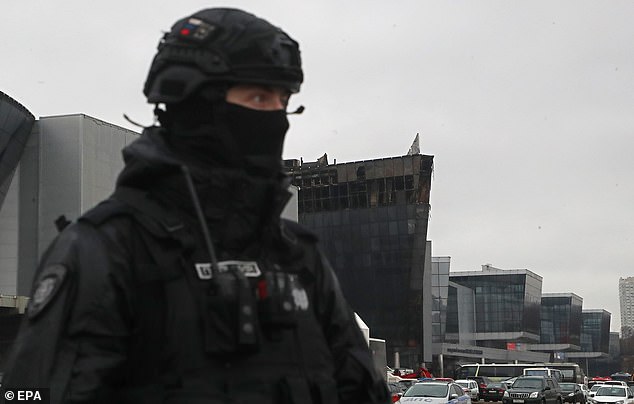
[203,270,259,356]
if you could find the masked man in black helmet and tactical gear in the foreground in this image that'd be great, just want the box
[3,8,389,404]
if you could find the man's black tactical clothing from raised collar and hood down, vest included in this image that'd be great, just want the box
[3,128,389,404]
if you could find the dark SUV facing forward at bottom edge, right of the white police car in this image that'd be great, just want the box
[502,376,562,404]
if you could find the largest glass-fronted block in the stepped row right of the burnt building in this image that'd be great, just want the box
[449,265,542,349]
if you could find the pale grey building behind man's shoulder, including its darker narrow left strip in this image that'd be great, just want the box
[13,114,138,294]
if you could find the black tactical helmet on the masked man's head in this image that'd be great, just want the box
[143,8,303,103]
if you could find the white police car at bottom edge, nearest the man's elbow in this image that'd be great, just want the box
[398,381,471,404]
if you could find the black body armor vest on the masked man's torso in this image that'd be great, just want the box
[80,187,337,404]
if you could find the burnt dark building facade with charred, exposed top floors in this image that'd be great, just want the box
[286,154,433,367]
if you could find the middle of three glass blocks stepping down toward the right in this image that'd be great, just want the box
[540,293,583,349]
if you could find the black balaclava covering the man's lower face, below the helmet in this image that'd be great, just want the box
[157,92,289,176]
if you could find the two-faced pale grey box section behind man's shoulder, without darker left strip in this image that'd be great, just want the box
[38,114,138,257]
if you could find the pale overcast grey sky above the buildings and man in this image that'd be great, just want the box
[0,0,634,331]
